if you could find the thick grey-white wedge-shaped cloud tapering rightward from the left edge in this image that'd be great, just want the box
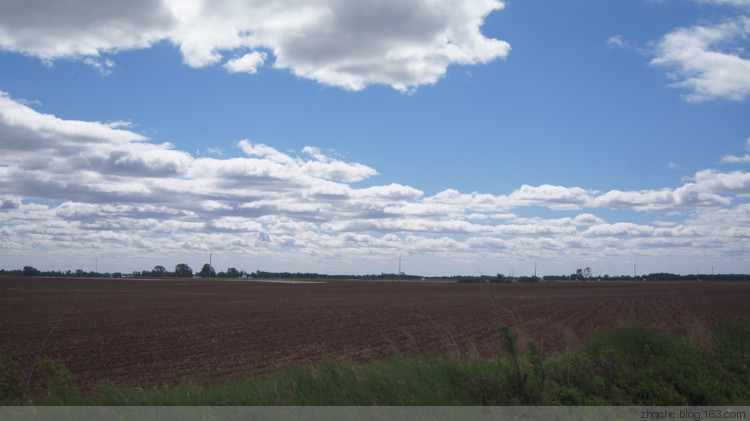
[0,93,387,210]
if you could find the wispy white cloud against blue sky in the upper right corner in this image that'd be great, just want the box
[651,16,750,102]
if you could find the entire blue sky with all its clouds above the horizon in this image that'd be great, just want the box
[0,0,750,276]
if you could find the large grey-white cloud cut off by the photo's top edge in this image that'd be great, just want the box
[0,0,510,91]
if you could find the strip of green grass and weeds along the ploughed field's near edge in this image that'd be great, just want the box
[5,319,750,406]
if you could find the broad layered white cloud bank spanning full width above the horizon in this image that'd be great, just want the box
[0,93,750,274]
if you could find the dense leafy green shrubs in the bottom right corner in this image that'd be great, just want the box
[546,325,750,406]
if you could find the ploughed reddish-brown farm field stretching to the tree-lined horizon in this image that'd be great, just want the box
[0,278,750,387]
